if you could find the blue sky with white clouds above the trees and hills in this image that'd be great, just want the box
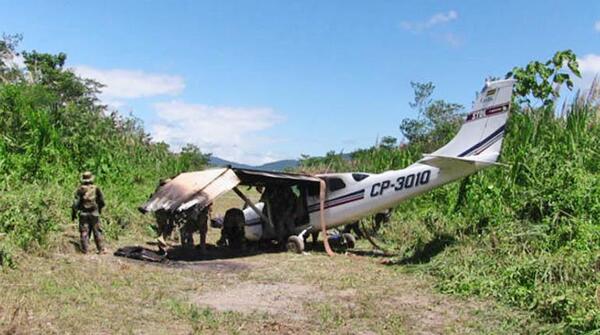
[0,0,600,164]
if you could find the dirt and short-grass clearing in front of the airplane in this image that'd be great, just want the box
[0,228,535,334]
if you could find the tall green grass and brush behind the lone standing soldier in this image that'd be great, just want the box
[0,59,207,267]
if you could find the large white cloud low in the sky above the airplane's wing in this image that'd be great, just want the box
[151,101,283,164]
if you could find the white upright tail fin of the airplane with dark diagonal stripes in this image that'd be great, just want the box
[425,79,515,164]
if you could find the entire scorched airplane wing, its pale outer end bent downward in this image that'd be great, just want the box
[139,168,320,213]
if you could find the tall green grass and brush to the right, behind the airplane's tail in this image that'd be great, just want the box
[298,85,600,333]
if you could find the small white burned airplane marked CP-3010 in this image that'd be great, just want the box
[140,79,514,253]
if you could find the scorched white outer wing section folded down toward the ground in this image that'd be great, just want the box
[139,168,240,213]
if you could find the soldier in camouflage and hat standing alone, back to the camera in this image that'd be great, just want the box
[71,171,105,253]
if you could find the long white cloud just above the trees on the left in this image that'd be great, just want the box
[73,65,185,101]
